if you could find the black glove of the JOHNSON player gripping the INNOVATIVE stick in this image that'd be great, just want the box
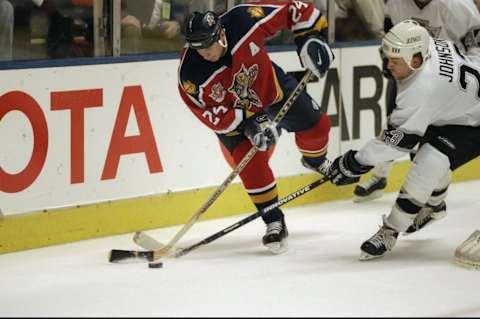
[328,150,373,185]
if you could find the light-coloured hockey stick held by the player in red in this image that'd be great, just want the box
[110,70,312,261]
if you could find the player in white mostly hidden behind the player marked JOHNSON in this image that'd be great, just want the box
[354,0,480,208]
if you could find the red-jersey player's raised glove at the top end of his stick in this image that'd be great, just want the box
[295,32,335,78]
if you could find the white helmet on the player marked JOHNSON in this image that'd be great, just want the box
[382,19,430,70]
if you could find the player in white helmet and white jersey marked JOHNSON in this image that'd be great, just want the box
[328,20,480,260]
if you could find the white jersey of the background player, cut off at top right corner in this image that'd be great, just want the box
[385,0,480,55]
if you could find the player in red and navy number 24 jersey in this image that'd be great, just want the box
[178,1,334,253]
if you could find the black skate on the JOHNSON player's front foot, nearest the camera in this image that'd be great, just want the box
[360,215,398,260]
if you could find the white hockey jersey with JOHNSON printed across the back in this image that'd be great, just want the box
[355,39,480,166]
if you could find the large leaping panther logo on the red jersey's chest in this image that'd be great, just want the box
[228,64,262,110]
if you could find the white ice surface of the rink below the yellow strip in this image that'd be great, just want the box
[0,181,480,317]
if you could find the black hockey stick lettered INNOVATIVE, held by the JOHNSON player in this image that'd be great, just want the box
[110,177,328,262]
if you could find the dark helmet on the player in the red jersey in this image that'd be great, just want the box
[184,11,222,49]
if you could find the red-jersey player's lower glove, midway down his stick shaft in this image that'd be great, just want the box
[243,112,280,151]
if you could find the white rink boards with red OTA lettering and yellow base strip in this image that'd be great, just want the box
[0,45,480,253]
